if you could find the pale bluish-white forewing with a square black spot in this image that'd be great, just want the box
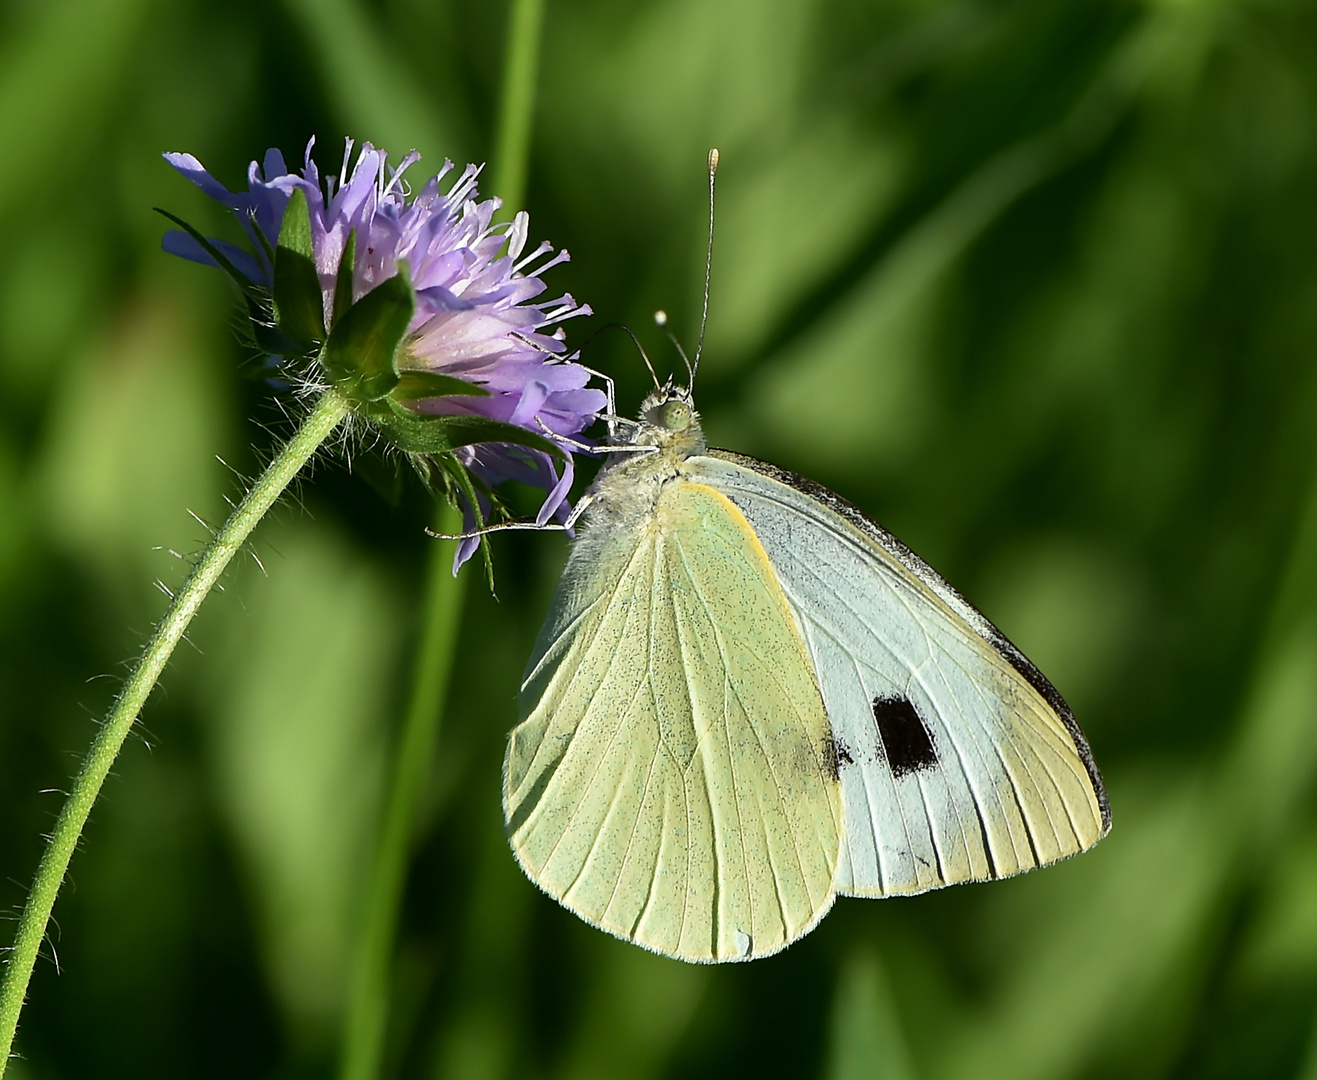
[686,450,1110,896]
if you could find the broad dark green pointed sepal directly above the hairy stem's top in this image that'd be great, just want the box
[320,262,416,402]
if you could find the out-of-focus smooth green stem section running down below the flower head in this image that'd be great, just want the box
[340,504,465,1080]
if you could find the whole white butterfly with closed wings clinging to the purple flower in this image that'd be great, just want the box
[503,386,1110,961]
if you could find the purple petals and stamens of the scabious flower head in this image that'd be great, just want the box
[163,140,606,572]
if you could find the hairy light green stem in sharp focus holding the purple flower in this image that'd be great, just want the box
[0,390,349,1076]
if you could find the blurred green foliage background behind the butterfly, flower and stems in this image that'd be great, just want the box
[0,0,1317,1080]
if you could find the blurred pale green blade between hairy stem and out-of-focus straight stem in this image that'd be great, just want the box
[205,520,406,1054]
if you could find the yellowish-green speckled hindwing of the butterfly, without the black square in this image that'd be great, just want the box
[503,479,842,961]
